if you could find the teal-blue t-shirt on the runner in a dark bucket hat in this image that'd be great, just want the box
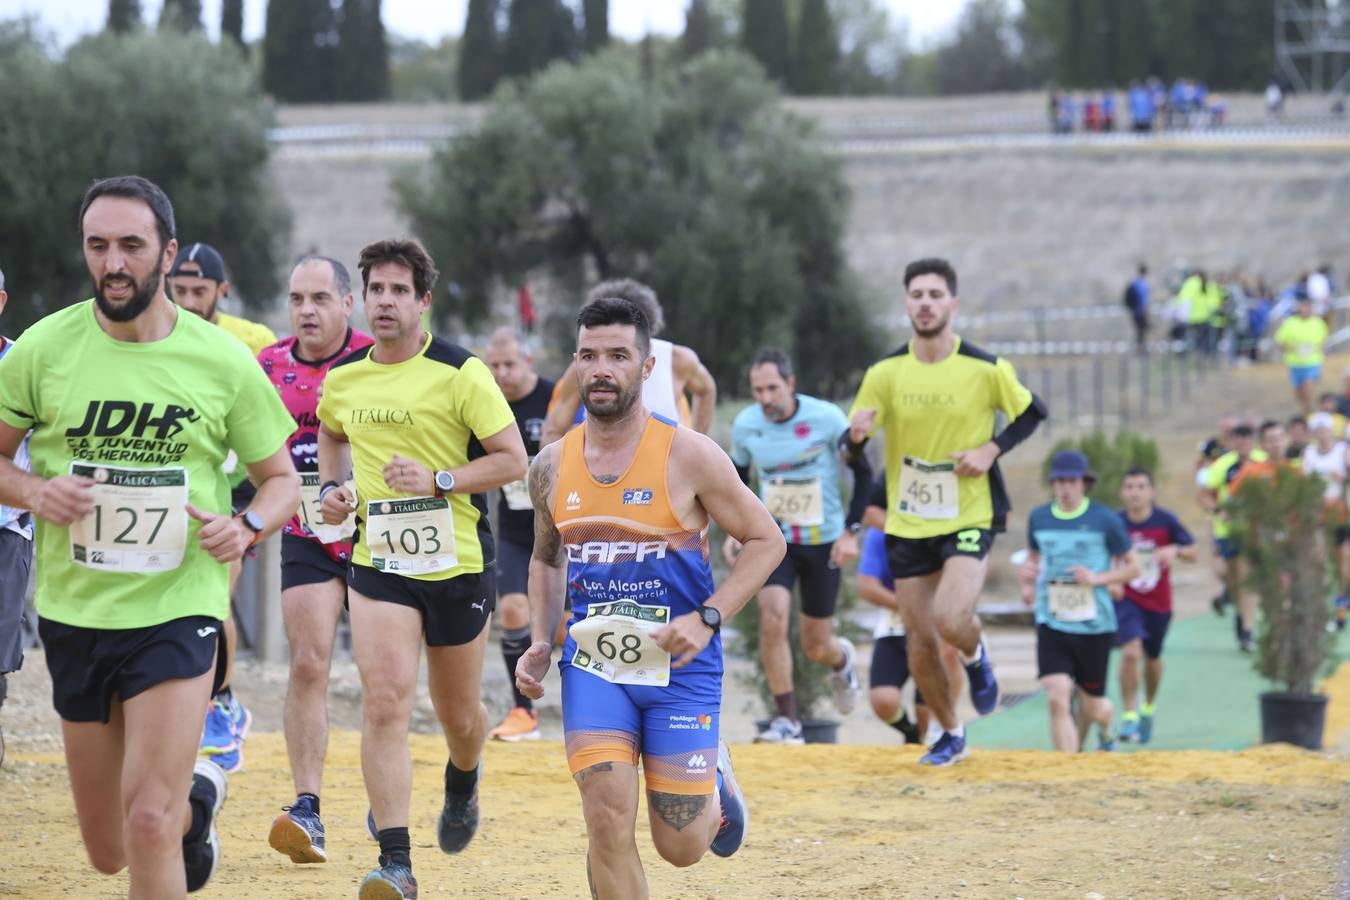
[1026,499,1130,634]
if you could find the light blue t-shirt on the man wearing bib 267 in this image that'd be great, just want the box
[732,394,847,545]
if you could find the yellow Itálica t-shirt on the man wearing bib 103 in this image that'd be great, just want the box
[319,335,516,582]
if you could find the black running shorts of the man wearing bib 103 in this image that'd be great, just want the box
[347,564,497,646]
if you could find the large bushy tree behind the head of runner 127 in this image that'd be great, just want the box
[0,31,289,332]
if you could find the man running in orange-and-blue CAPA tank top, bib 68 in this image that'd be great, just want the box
[516,297,784,900]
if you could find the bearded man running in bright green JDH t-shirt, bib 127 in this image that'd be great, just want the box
[0,175,300,897]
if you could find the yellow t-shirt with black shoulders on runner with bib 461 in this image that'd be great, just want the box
[849,337,1033,538]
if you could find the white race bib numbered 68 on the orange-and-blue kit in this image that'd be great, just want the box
[568,600,671,687]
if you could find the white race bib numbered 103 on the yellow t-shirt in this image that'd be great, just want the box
[366,497,459,575]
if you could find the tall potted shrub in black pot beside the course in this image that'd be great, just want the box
[1229,467,1334,750]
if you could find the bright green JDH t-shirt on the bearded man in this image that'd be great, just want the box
[0,300,296,629]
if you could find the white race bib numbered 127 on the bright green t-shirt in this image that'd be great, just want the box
[70,463,188,572]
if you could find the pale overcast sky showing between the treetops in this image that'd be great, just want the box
[0,0,967,46]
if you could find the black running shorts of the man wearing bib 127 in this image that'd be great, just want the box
[38,615,225,725]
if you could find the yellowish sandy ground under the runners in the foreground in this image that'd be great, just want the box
[0,656,1350,899]
